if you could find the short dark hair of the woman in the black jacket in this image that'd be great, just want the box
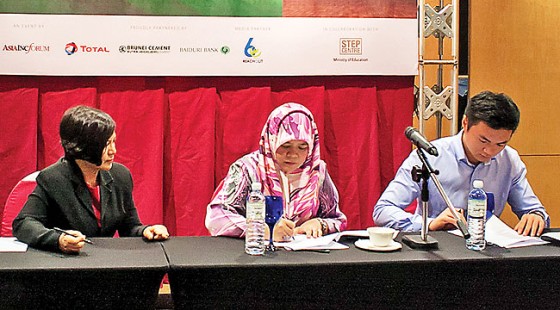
[60,105,115,166]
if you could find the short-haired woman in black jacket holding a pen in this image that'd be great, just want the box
[12,106,169,253]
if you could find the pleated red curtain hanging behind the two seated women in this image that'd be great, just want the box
[0,76,414,236]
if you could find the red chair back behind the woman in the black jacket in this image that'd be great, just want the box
[0,171,39,237]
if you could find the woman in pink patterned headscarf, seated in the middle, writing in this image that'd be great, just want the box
[206,103,346,241]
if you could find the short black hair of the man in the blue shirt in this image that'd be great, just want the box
[465,91,520,132]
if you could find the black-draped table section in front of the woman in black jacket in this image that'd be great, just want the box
[0,238,168,309]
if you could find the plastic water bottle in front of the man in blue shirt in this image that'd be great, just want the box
[467,180,487,251]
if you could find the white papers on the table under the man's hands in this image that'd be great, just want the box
[449,216,548,249]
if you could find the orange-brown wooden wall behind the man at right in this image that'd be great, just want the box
[469,0,560,227]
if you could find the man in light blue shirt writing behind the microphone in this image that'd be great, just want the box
[373,91,550,236]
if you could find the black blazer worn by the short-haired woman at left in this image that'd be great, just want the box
[12,158,146,250]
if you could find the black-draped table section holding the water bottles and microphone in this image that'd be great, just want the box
[163,232,560,309]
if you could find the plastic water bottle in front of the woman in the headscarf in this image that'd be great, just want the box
[245,182,266,255]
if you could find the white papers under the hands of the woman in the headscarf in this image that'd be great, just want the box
[274,230,368,251]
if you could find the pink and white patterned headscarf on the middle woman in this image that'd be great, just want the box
[257,103,326,222]
